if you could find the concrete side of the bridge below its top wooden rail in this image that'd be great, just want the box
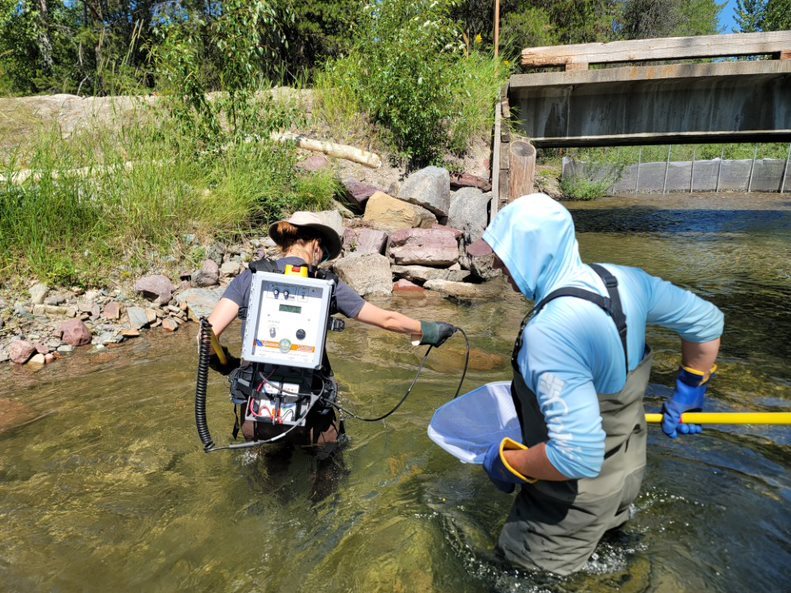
[508,60,791,147]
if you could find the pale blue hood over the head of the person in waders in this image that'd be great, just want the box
[483,194,590,302]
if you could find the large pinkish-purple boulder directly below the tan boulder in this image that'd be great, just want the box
[390,226,461,267]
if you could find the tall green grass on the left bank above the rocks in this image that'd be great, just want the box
[0,104,338,286]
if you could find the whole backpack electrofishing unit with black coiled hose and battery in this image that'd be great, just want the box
[195,260,344,451]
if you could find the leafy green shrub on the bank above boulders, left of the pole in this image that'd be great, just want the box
[317,0,507,166]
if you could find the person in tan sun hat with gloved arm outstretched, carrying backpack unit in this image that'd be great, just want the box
[209,212,456,456]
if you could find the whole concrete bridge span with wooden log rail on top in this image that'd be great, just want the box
[506,31,791,147]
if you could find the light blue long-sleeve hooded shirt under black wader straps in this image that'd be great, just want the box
[484,194,723,478]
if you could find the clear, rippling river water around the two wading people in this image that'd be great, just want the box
[0,194,791,593]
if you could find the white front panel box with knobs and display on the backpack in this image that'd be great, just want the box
[242,272,333,369]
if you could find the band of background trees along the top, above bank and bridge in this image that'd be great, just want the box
[0,0,756,94]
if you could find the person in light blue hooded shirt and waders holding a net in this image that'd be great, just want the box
[476,194,723,575]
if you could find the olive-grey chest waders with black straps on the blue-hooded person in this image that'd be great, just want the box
[498,265,652,575]
